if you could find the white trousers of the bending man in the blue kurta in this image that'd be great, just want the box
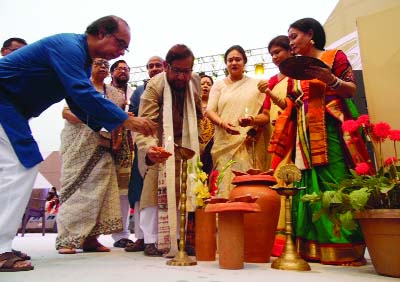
[0,124,39,254]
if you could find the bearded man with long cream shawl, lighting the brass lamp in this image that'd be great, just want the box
[136,44,202,257]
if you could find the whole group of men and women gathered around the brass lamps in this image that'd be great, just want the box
[0,16,372,272]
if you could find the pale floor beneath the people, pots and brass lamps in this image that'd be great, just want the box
[0,233,399,282]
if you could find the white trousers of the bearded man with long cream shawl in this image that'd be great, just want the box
[139,206,180,244]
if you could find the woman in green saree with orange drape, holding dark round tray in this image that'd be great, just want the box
[268,18,369,265]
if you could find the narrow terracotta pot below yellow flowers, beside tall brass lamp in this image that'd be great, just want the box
[195,209,217,261]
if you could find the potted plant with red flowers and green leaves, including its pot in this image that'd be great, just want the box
[301,115,400,277]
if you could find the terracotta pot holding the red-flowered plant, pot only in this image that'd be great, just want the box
[355,209,400,277]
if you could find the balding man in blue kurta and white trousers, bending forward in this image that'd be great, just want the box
[0,16,156,272]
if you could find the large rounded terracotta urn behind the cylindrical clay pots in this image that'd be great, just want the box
[229,174,281,263]
